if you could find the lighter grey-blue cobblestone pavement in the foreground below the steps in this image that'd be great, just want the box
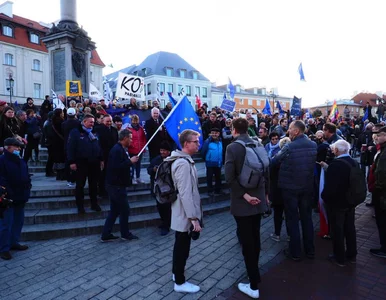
[0,207,296,300]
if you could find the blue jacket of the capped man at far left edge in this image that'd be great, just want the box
[0,150,31,205]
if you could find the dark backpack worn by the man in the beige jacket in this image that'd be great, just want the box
[154,157,185,204]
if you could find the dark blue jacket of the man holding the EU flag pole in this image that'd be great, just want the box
[106,143,133,187]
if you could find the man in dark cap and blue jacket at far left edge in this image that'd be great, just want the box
[0,138,31,260]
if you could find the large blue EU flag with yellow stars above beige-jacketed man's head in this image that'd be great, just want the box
[164,96,203,149]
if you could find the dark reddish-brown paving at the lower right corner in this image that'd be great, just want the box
[219,205,386,300]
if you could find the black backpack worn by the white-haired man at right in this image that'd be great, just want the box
[342,159,367,207]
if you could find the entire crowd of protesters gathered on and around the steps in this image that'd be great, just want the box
[0,97,386,298]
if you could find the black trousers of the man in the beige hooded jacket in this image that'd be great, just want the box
[173,231,191,285]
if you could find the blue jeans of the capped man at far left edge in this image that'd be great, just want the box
[0,206,24,252]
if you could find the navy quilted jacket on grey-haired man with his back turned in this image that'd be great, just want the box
[272,134,316,190]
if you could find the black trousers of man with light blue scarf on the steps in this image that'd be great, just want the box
[75,162,101,208]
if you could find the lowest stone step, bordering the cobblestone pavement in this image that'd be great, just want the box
[22,200,230,241]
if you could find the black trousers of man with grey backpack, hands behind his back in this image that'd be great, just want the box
[234,215,261,290]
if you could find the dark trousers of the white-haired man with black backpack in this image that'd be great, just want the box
[330,208,357,264]
